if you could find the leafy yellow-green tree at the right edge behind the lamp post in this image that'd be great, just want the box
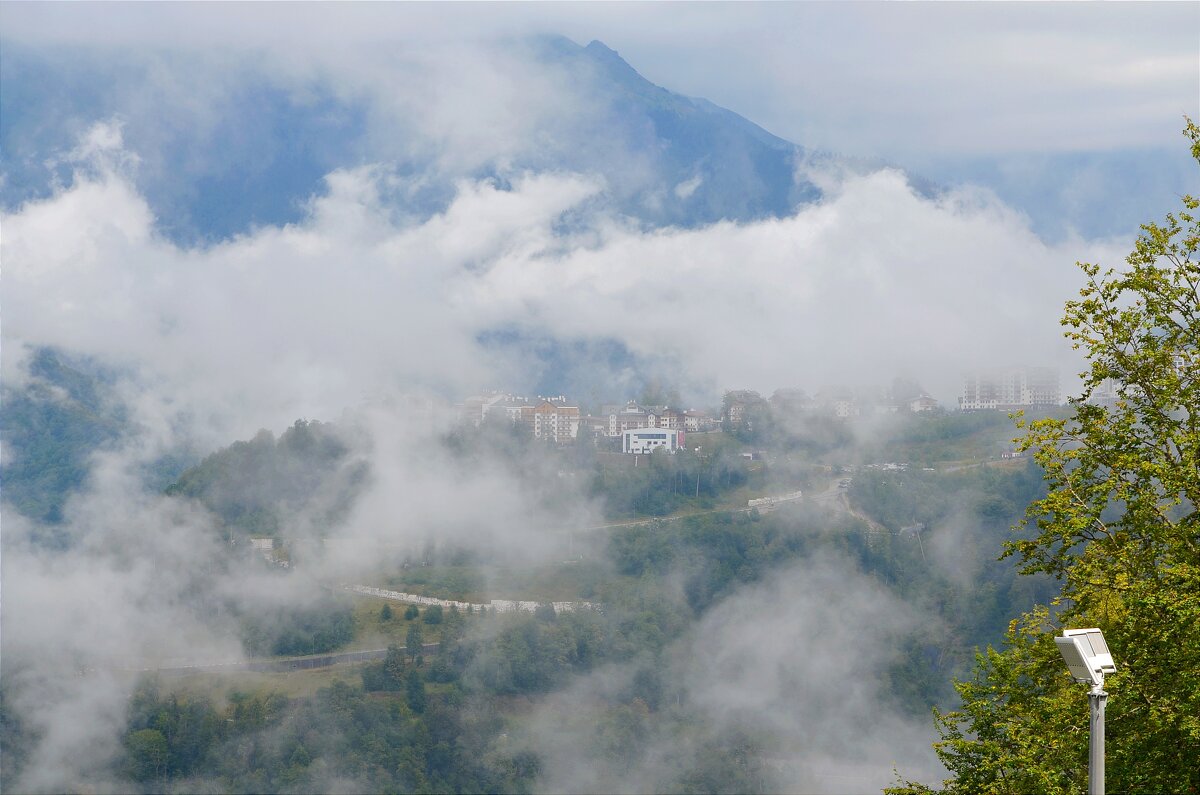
[893,120,1200,793]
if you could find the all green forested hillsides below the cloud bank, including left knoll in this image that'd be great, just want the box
[0,360,1070,793]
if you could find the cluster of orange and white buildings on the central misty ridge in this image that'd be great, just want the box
[462,393,718,452]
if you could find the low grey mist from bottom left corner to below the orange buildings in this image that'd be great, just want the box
[2,396,609,791]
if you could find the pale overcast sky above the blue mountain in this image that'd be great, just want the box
[0,2,1200,161]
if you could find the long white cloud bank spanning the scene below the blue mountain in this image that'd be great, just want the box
[2,125,1116,440]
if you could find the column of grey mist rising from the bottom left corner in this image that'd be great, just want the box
[2,456,245,793]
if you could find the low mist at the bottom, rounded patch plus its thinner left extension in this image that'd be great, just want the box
[525,555,942,793]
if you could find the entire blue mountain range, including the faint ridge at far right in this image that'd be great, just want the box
[0,36,1190,245]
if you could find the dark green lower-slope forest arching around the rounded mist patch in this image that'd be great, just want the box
[65,501,1046,793]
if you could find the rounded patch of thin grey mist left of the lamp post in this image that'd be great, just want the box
[680,557,942,793]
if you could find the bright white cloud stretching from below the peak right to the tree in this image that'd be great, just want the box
[463,172,1115,400]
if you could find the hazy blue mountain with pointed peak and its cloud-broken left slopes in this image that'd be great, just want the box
[0,36,849,244]
